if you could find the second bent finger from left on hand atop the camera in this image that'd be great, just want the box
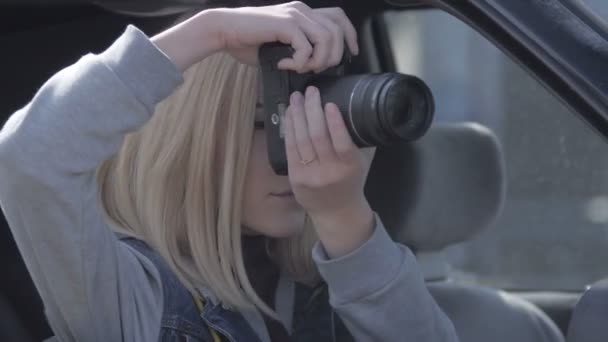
[296,12,332,72]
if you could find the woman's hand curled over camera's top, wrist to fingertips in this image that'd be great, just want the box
[221,1,358,72]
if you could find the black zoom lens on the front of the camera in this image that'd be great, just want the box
[311,73,435,147]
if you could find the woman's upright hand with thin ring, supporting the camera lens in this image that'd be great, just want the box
[285,87,375,258]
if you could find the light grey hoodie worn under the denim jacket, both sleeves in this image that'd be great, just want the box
[0,26,457,342]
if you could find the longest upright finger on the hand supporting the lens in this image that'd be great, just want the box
[304,87,336,163]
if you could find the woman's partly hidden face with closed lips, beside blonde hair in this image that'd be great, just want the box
[241,99,306,238]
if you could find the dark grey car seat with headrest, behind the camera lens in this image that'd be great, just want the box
[366,123,564,342]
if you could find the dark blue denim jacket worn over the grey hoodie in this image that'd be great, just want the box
[121,238,353,342]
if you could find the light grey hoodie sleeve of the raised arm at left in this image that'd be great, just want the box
[0,26,183,341]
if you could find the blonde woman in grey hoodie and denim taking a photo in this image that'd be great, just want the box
[0,2,456,341]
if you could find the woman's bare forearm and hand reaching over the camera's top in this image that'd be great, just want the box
[152,1,359,73]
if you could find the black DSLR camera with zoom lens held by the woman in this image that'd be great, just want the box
[259,43,435,175]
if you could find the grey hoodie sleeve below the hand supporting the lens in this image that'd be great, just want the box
[313,214,458,342]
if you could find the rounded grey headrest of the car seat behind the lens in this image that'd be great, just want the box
[365,123,506,251]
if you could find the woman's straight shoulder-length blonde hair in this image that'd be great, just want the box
[97,53,318,316]
